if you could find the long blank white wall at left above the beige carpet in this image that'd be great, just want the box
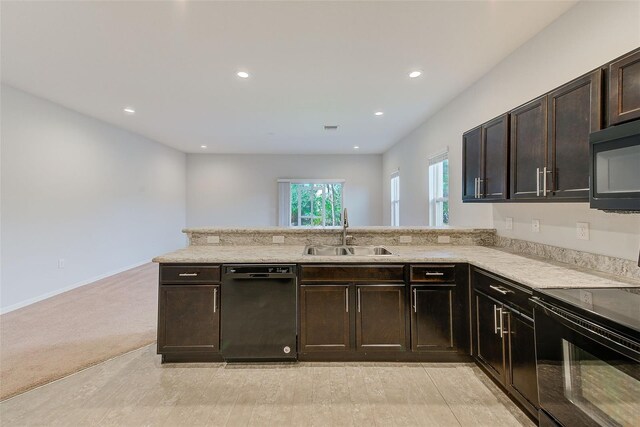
[0,85,186,311]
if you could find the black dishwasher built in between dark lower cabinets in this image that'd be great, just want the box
[220,264,297,362]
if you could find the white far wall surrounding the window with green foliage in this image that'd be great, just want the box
[187,154,382,227]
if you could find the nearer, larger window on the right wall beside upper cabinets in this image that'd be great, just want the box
[429,151,449,226]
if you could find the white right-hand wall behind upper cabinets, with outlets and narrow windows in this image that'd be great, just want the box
[383,1,640,259]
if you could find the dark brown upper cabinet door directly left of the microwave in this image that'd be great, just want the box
[547,70,602,201]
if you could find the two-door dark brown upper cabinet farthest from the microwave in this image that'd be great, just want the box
[462,114,509,201]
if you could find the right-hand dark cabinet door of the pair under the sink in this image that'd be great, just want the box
[356,285,407,351]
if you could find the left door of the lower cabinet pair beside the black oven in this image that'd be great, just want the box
[474,292,504,383]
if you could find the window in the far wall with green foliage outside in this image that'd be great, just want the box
[278,179,344,227]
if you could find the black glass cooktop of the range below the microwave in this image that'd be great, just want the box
[534,287,640,333]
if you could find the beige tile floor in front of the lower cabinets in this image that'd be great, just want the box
[0,345,534,427]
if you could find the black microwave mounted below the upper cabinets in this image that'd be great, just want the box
[589,120,640,212]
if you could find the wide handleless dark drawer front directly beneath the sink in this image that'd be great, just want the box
[300,265,404,283]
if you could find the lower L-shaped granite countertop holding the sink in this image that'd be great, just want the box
[153,245,640,289]
